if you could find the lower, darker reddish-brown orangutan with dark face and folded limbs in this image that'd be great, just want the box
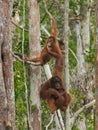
[39,76,71,113]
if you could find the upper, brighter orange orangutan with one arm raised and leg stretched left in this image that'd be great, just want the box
[25,19,59,65]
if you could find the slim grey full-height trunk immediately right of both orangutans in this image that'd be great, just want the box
[64,0,71,130]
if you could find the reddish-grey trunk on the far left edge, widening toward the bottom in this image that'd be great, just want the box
[0,45,7,130]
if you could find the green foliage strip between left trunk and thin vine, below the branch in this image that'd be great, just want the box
[14,62,27,130]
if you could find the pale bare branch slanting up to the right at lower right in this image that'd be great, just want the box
[71,100,95,126]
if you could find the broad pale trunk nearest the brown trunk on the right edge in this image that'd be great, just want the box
[80,3,94,129]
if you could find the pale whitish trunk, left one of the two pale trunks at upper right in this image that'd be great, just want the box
[76,9,86,130]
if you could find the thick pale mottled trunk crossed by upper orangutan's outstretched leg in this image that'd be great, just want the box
[29,0,41,130]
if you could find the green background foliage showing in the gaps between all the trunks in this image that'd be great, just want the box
[12,0,95,130]
